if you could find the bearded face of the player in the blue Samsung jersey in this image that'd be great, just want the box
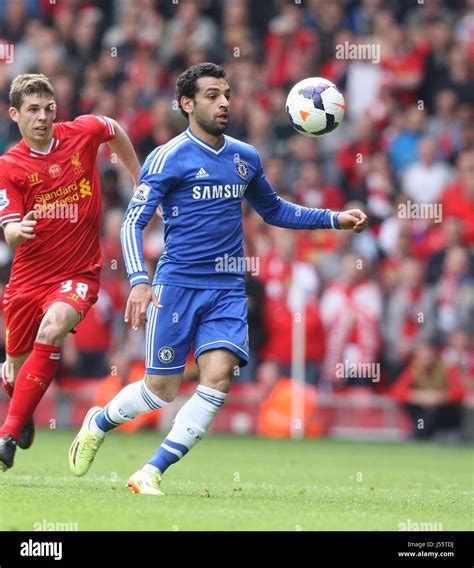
[192,77,230,136]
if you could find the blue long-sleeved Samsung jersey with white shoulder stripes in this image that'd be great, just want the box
[121,128,339,289]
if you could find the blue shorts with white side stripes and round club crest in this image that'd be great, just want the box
[145,284,249,375]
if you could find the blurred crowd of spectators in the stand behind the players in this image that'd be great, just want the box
[0,0,474,434]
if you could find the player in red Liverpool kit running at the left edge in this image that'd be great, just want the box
[0,74,140,470]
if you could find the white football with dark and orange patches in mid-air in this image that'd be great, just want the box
[286,77,346,136]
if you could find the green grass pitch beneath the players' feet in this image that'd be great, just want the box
[0,430,473,531]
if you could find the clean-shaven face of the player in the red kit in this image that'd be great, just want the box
[10,95,56,148]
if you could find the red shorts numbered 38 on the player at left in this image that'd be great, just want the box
[3,276,100,357]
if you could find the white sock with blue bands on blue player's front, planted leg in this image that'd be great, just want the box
[147,385,226,473]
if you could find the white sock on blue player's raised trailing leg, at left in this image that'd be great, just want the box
[90,380,169,436]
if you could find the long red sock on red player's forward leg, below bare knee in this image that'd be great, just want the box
[0,341,61,441]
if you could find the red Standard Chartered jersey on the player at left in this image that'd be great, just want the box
[0,115,115,289]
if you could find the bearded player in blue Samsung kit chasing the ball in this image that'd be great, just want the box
[69,63,367,495]
